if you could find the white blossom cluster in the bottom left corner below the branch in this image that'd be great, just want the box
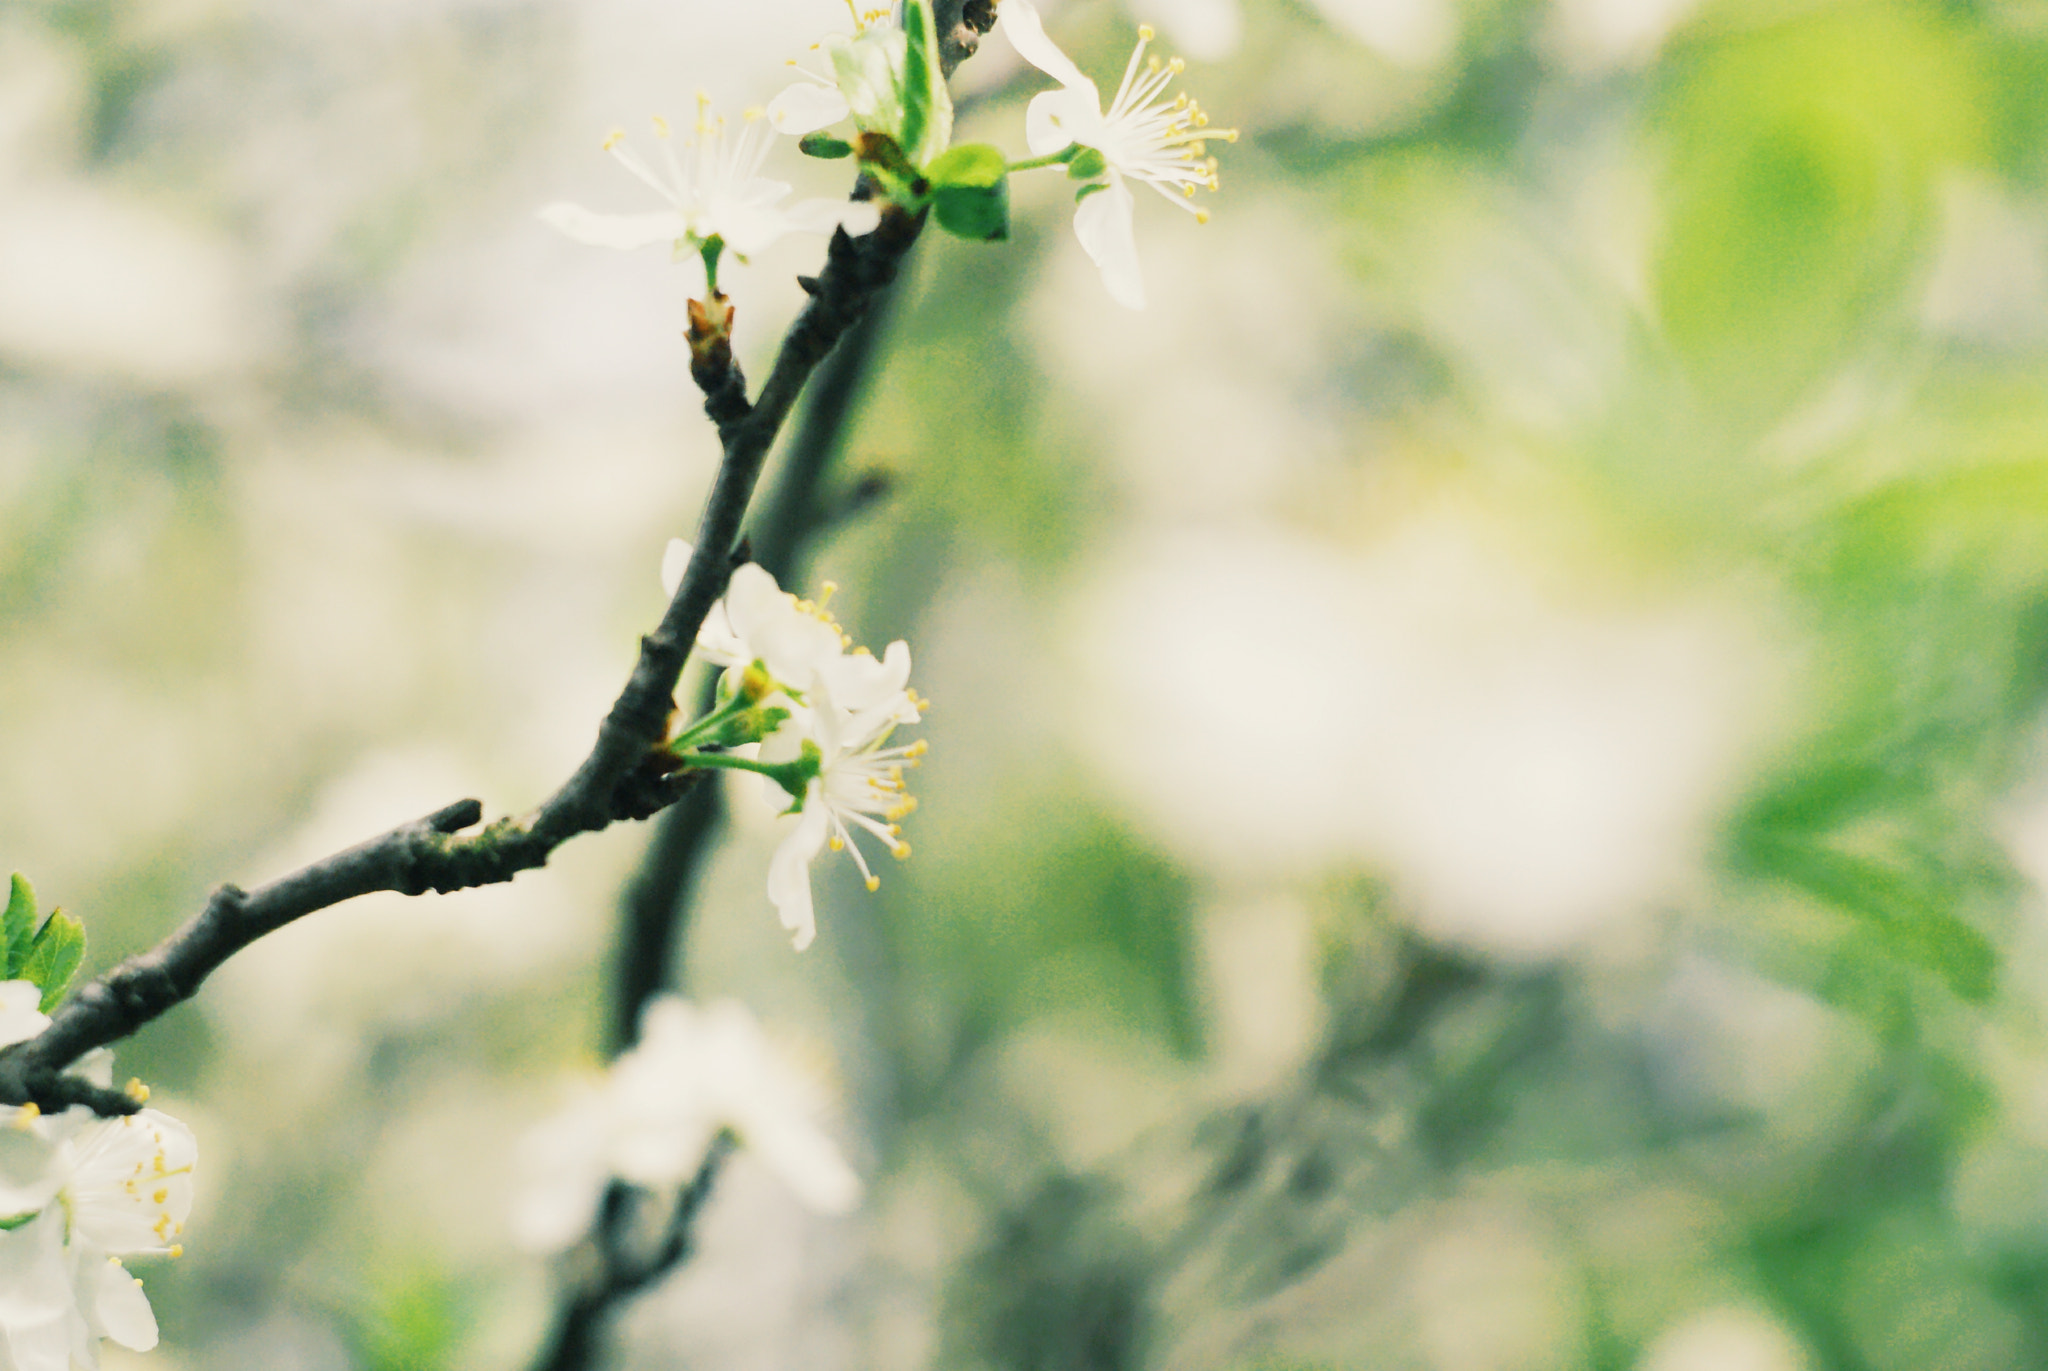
[0,980,199,1371]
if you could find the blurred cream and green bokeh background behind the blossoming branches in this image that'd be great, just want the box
[0,0,2048,1371]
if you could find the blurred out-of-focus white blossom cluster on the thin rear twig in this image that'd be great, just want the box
[512,996,860,1252]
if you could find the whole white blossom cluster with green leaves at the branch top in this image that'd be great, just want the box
[541,0,1237,318]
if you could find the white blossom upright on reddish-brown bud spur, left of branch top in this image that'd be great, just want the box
[541,100,881,287]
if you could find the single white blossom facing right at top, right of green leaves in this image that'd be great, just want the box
[997,0,1237,309]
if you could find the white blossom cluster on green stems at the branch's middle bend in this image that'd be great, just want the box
[662,539,930,951]
